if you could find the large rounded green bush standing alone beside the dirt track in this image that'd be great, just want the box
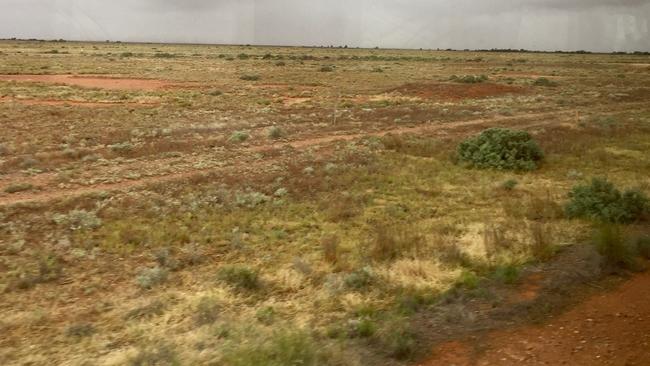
[458,128,544,170]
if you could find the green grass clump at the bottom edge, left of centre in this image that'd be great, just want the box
[223,330,322,366]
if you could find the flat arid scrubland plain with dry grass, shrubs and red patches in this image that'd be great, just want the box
[0,41,650,366]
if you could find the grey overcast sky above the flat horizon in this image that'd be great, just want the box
[0,0,650,51]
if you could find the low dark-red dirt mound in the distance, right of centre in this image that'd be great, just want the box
[388,83,526,100]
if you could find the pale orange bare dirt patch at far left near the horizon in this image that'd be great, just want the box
[0,75,173,90]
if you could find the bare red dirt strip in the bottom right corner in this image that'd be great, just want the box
[419,273,650,366]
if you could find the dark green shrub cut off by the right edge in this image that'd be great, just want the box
[565,178,649,223]
